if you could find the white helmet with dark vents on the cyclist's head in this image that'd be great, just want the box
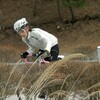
[14,18,28,32]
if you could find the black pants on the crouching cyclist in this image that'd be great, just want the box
[40,44,59,61]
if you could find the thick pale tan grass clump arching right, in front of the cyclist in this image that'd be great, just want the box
[27,54,84,96]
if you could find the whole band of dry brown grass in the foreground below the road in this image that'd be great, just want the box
[0,54,100,100]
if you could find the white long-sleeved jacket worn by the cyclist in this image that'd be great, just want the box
[22,28,58,53]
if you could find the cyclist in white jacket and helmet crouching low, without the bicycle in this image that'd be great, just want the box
[14,18,59,62]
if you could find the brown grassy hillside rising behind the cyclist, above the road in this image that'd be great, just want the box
[0,0,100,57]
